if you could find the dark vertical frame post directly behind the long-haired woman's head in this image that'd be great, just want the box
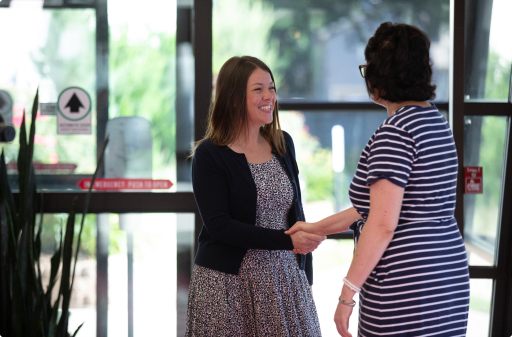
[193,0,212,141]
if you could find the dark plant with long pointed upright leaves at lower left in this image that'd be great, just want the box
[0,88,108,337]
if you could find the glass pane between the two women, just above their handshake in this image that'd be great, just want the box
[279,109,387,217]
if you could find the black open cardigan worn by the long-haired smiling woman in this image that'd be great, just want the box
[192,132,313,284]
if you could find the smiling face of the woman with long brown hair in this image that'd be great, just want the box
[247,68,277,128]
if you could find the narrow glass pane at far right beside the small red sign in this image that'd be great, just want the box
[464,116,508,266]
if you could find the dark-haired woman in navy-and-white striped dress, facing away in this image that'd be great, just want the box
[288,22,469,337]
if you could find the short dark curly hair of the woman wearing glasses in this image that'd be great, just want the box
[364,22,436,103]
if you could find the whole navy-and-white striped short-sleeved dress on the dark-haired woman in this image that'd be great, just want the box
[349,106,469,337]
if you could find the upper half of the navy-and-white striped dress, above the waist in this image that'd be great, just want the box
[349,106,458,224]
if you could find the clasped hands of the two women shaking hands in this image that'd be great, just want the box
[284,221,327,254]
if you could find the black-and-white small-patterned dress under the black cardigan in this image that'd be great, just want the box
[185,157,321,337]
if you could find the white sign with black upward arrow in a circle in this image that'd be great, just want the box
[57,87,91,135]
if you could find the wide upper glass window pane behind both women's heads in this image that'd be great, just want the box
[213,0,450,102]
